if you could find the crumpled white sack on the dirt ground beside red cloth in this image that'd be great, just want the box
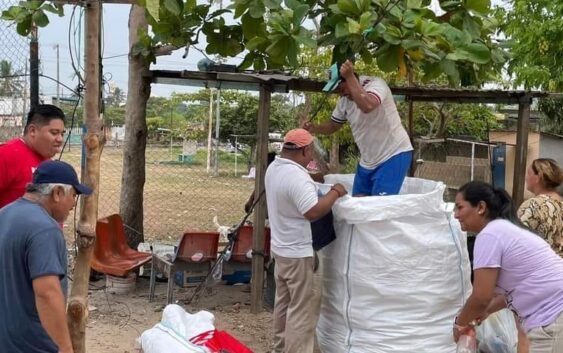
[139,304,215,353]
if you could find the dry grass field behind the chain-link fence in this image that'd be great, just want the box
[62,146,254,243]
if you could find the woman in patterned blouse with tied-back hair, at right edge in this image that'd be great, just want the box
[518,158,563,256]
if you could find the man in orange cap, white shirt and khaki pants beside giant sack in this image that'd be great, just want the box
[265,129,347,353]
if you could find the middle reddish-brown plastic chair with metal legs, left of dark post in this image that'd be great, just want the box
[149,232,219,304]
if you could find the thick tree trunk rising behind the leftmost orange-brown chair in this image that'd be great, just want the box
[119,5,151,249]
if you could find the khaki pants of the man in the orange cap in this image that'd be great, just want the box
[274,255,318,353]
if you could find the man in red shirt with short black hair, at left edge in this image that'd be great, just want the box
[0,104,65,208]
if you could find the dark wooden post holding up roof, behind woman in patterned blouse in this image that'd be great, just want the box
[512,95,532,207]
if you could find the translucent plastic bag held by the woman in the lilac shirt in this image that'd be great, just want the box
[477,309,518,353]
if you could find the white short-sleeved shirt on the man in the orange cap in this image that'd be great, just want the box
[265,157,319,258]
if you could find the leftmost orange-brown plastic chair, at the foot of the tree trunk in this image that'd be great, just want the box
[90,215,151,277]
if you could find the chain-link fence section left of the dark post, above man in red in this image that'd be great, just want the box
[0,0,29,141]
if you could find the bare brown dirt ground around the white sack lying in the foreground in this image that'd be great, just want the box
[86,277,272,353]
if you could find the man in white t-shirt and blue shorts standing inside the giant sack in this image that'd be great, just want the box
[303,61,413,196]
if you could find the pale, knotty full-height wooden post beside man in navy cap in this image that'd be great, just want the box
[67,1,104,353]
